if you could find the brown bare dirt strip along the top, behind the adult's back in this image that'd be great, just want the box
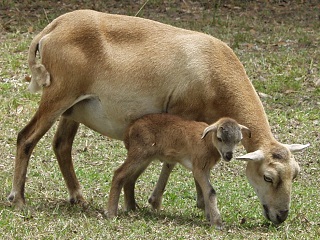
[0,0,320,32]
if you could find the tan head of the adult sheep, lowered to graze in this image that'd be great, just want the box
[237,142,309,224]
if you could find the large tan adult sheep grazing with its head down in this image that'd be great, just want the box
[9,10,307,227]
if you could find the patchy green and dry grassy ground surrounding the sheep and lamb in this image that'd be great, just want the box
[0,0,320,239]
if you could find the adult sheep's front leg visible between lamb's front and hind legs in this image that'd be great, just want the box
[148,163,176,210]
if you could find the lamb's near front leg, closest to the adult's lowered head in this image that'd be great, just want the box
[193,169,222,229]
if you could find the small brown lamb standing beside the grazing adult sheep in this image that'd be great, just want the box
[108,114,250,227]
